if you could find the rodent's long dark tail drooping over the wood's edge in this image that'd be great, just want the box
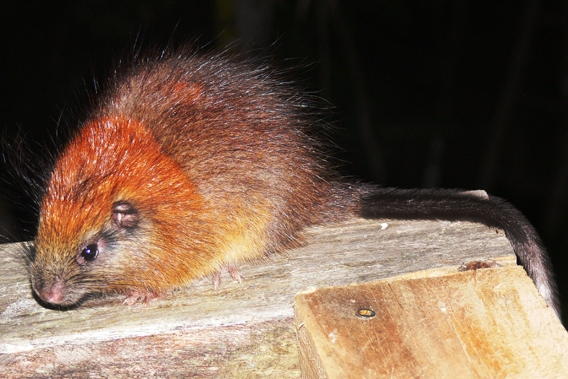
[359,187,560,318]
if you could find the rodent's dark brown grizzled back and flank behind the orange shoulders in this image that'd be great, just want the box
[101,55,344,255]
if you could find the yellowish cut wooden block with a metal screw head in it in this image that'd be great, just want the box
[295,266,568,379]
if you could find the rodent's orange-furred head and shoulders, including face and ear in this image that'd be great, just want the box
[30,119,201,306]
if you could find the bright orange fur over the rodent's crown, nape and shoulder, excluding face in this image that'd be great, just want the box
[36,119,220,288]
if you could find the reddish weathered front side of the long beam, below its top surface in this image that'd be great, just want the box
[0,319,300,379]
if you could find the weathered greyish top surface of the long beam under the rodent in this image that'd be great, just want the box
[0,219,515,377]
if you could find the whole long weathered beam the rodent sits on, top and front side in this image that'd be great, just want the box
[0,219,515,378]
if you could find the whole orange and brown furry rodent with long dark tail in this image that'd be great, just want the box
[30,52,559,315]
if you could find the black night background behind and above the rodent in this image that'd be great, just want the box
[0,0,568,322]
